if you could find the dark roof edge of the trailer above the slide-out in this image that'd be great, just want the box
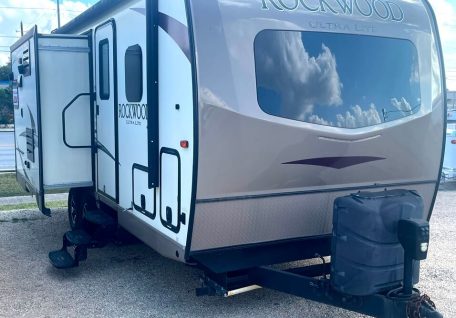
[52,0,125,34]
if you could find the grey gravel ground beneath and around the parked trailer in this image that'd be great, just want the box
[0,190,456,318]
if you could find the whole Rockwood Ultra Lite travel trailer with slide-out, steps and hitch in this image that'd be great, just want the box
[11,0,446,317]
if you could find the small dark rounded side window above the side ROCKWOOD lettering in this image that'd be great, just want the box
[125,45,143,102]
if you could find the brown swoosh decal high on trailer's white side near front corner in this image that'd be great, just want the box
[131,8,191,61]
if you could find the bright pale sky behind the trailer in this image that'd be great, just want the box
[0,0,456,90]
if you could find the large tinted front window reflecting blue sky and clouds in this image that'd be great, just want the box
[255,30,421,128]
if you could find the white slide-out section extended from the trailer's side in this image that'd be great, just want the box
[11,27,93,215]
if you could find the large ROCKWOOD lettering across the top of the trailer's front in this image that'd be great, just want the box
[261,0,404,22]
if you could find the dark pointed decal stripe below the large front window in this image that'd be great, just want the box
[283,156,386,169]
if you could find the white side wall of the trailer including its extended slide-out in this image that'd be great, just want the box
[12,1,194,261]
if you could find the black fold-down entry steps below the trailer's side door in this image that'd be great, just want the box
[49,210,117,269]
